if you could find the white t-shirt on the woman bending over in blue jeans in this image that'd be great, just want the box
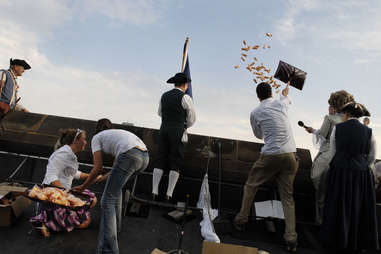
[91,129,147,158]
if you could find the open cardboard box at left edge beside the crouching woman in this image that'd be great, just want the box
[0,185,31,227]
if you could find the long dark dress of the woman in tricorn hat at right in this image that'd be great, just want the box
[321,119,381,251]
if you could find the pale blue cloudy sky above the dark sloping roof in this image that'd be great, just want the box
[0,0,381,158]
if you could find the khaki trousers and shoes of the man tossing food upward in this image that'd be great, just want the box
[234,153,298,242]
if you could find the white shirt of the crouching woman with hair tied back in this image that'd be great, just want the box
[42,145,82,190]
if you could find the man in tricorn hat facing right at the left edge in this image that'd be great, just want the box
[0,58,31,117]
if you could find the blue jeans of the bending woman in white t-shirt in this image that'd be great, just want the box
[97,148,149,254]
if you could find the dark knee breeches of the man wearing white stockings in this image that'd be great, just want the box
[155,124,184,171]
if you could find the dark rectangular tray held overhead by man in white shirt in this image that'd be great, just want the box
[274,61,307,90]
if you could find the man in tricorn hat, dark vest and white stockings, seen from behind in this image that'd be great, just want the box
[152,72,196,200]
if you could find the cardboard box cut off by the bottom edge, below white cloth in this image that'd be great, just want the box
[202,241,258,254]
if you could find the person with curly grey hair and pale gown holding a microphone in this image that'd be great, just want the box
[306,90,354,225]
